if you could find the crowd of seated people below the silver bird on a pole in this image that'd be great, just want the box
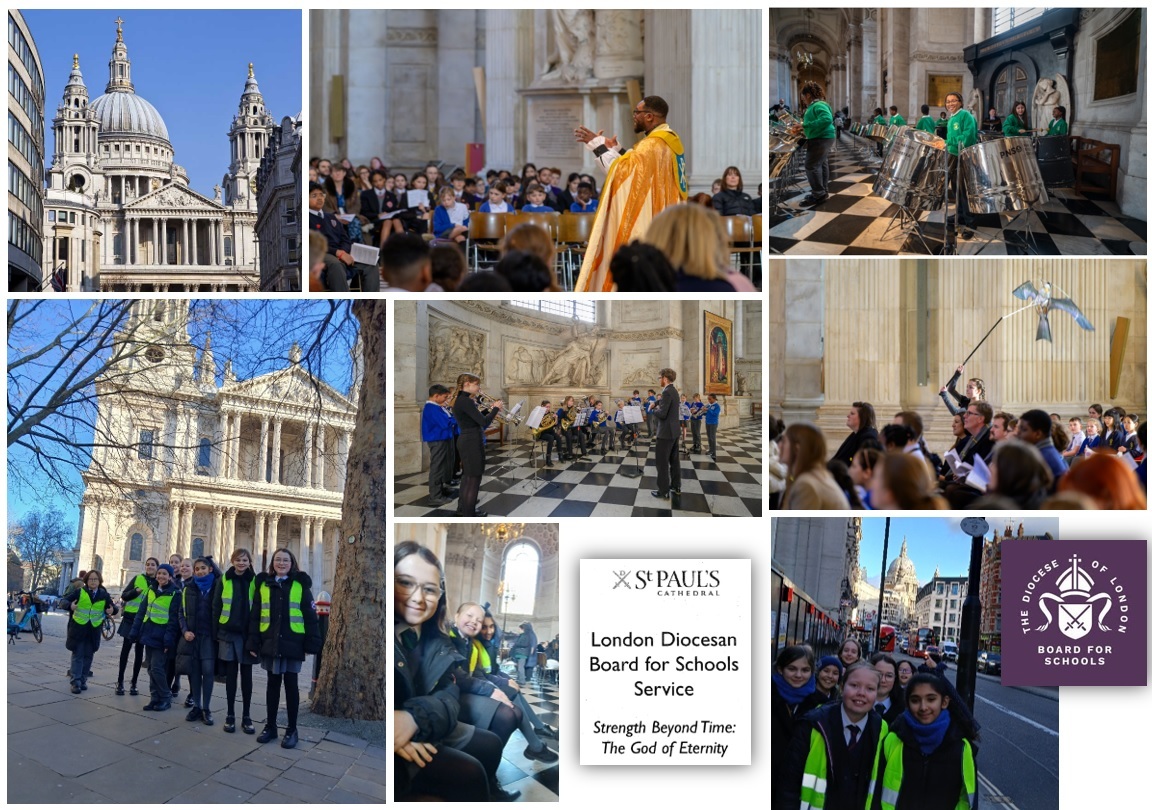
[768,400,1147,510]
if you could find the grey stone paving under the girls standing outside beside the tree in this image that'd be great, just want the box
[7,613,389,803]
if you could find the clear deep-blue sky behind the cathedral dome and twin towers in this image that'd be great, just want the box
[23,9,302,197]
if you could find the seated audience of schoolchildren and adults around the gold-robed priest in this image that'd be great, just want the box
[309,158,763,293]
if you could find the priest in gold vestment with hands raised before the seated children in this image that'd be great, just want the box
[576,96,688,293]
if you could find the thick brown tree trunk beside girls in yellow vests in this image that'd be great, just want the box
[312,301,392,720]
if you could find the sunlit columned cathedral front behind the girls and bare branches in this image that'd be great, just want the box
[75,300,356,593]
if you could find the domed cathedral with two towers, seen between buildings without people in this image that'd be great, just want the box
[44,20,274,293]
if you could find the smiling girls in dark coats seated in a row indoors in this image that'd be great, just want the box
[393,540,559,802]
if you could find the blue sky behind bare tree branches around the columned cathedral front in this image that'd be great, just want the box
[6,300,358,525]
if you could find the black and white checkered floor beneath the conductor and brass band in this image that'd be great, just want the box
[395,419,764,517]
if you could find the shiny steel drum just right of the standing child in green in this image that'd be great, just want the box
[960,138,1048,214]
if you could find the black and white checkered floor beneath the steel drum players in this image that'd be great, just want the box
[768,135,1147,256]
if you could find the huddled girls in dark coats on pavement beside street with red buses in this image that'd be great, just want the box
[772,645,978,810]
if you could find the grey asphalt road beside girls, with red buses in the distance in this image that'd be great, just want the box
[894,653,1060,810]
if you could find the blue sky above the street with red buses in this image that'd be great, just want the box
[861,513,1060,585]
